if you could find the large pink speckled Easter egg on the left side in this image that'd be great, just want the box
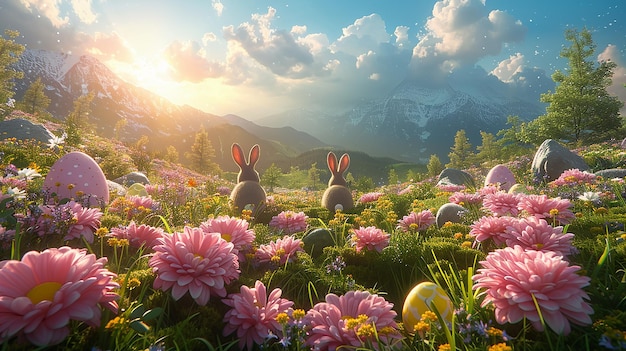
[43,151,109,206]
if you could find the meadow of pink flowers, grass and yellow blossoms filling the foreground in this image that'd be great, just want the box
[0,128,626,351]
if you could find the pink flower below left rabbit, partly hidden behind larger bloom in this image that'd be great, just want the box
[200,216,255,262]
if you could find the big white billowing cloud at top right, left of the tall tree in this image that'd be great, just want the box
[411,0,526,80]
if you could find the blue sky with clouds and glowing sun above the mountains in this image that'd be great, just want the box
[0,0,626,119]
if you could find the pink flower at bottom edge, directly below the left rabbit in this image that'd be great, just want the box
[222,280,293,350]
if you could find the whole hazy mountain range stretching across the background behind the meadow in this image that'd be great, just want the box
[16,50,553,175]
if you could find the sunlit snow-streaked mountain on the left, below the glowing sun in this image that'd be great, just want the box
[16,50,225,141]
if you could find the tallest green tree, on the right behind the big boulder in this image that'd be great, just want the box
[530,29,623,145]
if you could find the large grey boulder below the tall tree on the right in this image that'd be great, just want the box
[531,139,589,182]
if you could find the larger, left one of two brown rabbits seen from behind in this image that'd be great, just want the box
[230,143,267,212]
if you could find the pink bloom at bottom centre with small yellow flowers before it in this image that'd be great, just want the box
[304,291,402,351]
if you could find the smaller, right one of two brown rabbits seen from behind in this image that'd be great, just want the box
[322,151,354,213]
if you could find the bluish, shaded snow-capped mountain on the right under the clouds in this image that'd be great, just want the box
[258,68,553,163]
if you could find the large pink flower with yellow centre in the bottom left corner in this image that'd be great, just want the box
[0,246,119,346]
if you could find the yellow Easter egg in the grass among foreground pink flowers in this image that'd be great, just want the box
[402,282,453,333]
